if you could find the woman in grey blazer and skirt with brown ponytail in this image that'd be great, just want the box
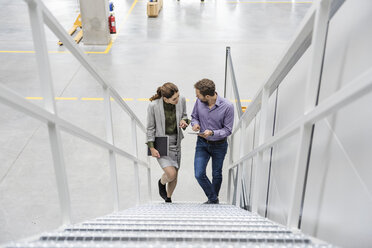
[147,83,190,202]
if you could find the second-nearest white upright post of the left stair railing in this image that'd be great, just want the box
[103,87,119,211]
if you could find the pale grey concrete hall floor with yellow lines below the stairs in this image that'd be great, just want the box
[0,0,311,243]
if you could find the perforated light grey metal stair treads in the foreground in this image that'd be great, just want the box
[6,203,331,248]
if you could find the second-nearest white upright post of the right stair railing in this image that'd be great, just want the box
[252,86,270,213]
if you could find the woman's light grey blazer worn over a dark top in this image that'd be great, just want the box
[147,96,187,148]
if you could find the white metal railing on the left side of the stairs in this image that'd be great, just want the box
[0,0,151,227]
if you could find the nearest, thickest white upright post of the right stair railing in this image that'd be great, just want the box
[287,0,332,228]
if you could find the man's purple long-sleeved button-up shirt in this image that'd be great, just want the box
[191,95,234,141]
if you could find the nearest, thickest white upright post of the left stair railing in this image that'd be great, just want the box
[26,0,71,225]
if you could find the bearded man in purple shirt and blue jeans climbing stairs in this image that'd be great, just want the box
[191,79,234,204]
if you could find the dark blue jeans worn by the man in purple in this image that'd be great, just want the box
[194,137,228,201]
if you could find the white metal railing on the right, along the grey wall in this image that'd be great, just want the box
[226,0,372,228]
